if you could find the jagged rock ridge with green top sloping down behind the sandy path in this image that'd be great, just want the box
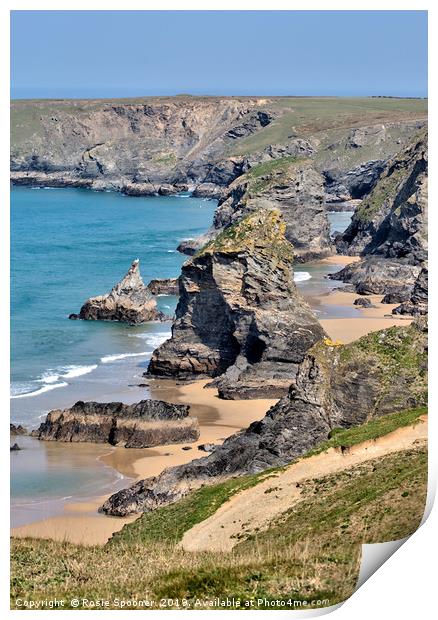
[100,321,427,516]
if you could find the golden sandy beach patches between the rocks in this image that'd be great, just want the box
[11,255,412,545]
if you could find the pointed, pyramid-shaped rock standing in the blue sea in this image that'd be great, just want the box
[69,259,166,324]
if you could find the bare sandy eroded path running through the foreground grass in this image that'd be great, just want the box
[180,416,427,551]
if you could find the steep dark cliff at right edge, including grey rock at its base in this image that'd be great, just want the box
[332,132,428,301]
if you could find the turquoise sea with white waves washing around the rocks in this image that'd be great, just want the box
[11,187,352,525]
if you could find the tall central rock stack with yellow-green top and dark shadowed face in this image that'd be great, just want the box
[148,209,324,398]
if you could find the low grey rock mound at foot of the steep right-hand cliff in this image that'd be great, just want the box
[328,256,420,295]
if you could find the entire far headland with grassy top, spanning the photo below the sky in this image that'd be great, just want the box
[11,96,427,200]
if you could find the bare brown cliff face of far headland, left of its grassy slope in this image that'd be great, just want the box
[11,97,273,194]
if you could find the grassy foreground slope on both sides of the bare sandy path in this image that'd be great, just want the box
[12,409,427,608]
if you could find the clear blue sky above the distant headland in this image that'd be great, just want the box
[11,11,427,98]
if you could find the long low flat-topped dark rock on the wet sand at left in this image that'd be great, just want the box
[33,400,199,448]
